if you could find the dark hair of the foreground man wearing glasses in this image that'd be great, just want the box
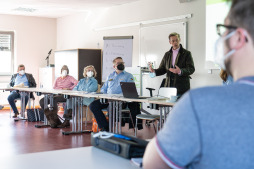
[228,0,254,42]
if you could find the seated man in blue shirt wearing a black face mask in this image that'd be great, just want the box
[89,57,142,131]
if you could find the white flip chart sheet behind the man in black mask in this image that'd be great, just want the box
[102,38,133,81]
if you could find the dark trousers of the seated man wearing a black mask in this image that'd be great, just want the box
[89,100,143,129]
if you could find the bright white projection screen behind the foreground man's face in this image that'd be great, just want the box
[206,0,230,69]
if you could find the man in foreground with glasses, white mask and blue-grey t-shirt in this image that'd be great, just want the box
[144,0,254,169]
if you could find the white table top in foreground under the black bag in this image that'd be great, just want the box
[0,147,138,169]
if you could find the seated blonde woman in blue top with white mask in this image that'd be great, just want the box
[58,65,98,128]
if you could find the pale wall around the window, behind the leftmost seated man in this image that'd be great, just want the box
[0,15,56,103]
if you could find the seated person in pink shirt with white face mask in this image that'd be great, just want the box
[40,65,78,128]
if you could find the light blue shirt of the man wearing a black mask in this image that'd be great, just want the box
[101,71,134,94]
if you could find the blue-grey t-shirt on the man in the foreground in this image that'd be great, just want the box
[156,77,254,169]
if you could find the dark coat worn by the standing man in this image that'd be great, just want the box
[155,45,195,95]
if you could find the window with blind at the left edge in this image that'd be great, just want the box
[0,31,14,75]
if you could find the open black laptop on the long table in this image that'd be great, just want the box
[120,82,150,99]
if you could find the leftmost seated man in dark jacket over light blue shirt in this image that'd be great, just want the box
[8,64,36,118]
